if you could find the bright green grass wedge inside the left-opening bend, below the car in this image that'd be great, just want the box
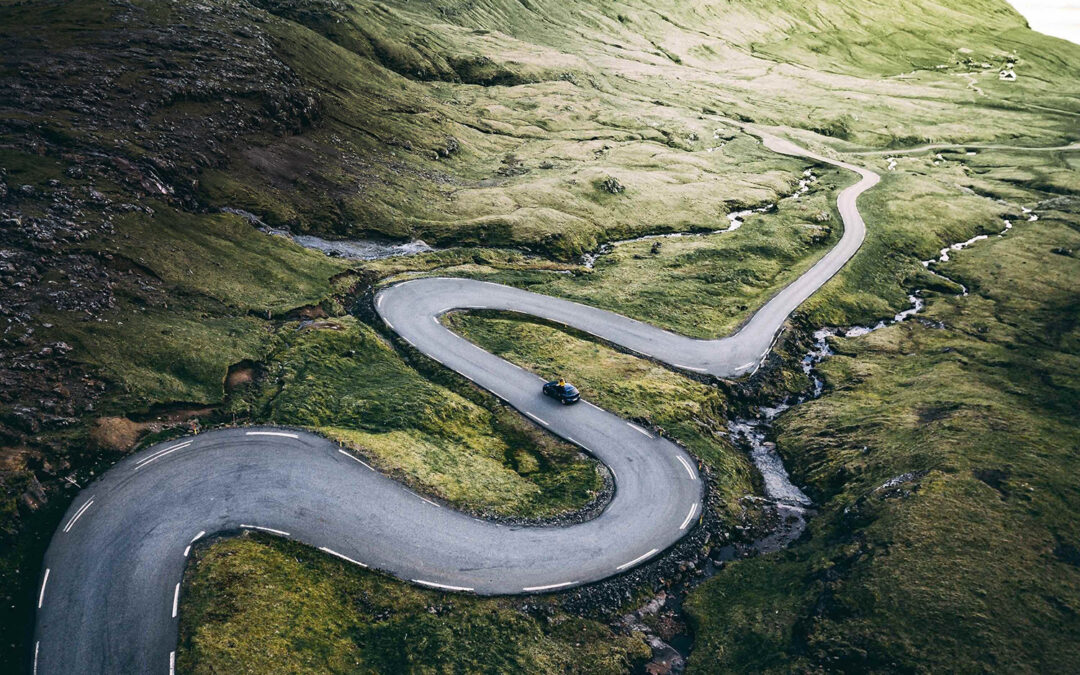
[227,318,603,517]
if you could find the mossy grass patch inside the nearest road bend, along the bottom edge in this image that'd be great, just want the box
[177,537,649,674]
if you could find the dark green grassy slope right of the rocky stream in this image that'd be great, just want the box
[688,173,1080,672]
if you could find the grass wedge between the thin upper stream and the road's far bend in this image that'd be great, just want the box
[451,172,847,338]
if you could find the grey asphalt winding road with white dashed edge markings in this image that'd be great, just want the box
[32,129,879,673]
